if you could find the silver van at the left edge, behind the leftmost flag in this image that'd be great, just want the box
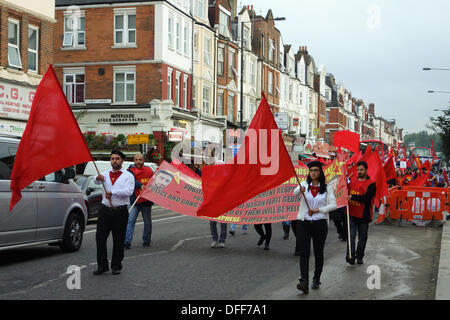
[0,136,87,252]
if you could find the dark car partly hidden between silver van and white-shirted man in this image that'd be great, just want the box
[73,174,103,219]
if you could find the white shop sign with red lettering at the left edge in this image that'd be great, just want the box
[0,82,36,120]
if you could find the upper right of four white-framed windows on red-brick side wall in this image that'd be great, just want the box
[114,10,136,46]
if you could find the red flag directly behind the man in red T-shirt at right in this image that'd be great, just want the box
[348,148,389,206]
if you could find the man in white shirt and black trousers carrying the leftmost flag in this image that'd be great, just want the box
[94,150,134,275]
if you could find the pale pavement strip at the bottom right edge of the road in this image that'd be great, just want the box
[436,221,450,300]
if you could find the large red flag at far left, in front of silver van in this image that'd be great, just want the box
[9,65,93,211]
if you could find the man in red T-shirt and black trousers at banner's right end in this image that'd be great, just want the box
[346,161,377,265]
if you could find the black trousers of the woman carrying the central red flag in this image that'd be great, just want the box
[297,219,328,282]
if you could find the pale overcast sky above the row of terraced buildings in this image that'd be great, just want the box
[238,0,450,132]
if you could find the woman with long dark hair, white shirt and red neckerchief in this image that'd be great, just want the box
[294,161,336,293]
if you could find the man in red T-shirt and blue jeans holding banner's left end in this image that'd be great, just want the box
[124,153,153,249]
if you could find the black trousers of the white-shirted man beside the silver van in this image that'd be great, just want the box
[95,205,128,270]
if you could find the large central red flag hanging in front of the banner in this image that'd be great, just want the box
[197,93,295,217]
